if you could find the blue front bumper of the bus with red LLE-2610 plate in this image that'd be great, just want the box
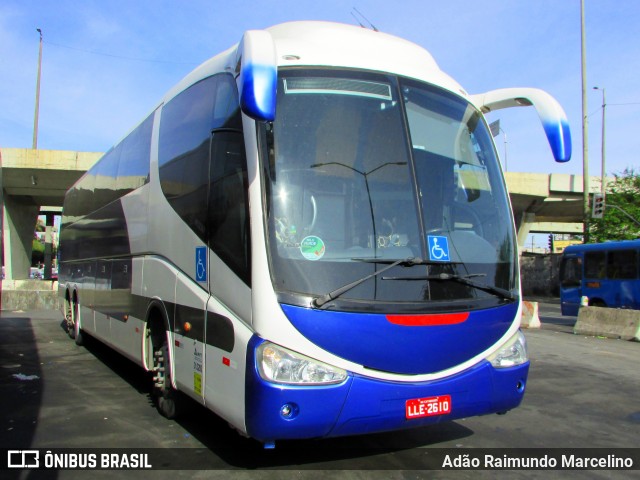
[245,338,529,443]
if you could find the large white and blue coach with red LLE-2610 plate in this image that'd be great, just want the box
[60,22,571,447]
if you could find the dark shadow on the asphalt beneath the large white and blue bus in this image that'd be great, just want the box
[75,326,474,470]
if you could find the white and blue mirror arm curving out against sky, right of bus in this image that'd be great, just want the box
[471,88,571,162]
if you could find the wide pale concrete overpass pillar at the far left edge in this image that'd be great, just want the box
[3,195,40,280]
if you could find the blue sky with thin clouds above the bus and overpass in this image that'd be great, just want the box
[0,0,640,175]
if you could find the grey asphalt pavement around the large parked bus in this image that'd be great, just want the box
[0,303,640,479]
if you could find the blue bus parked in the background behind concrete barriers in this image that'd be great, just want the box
[560,240,640,316]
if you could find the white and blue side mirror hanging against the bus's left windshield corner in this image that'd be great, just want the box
[236,30,278,121]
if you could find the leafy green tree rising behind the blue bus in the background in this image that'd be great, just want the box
[589,168,640,243]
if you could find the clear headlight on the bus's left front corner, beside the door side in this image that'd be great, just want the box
[257,342,347,385]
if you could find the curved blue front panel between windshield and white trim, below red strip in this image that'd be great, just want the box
[282,303,518,375]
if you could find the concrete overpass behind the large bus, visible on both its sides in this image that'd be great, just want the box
[0,148,599,280]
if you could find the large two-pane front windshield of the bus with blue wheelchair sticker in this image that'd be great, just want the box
[264,69,518,312]
